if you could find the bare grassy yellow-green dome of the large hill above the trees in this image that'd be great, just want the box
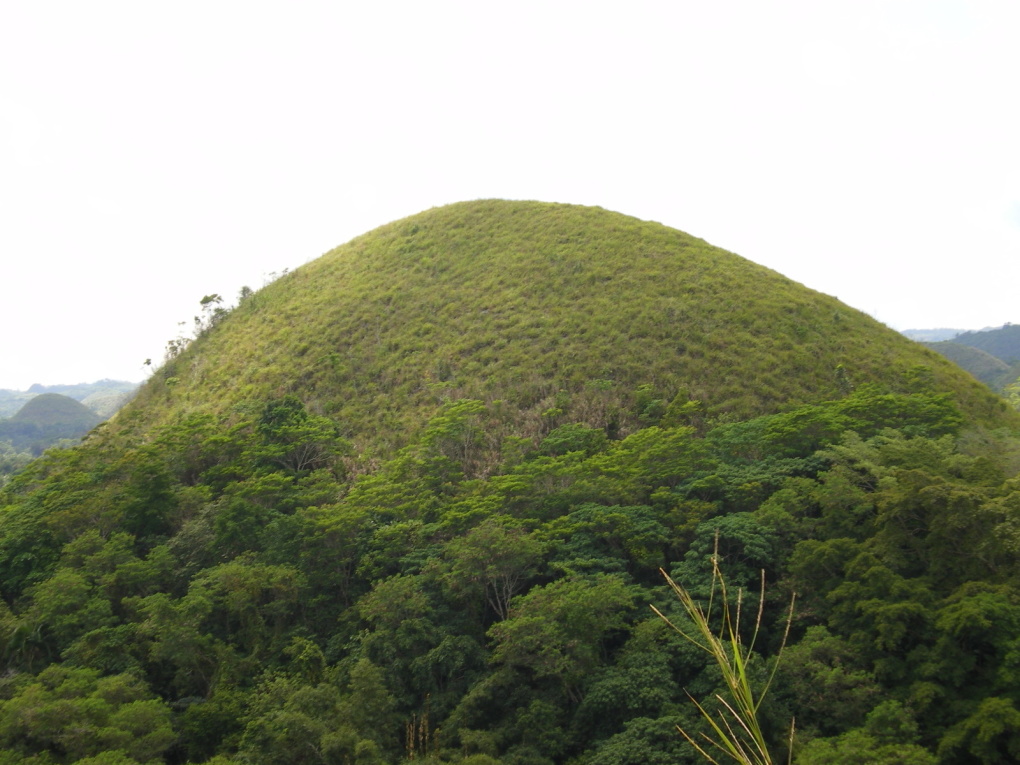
[123,200,1003,454]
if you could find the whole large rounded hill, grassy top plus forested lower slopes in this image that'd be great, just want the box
[0,202,1020,765]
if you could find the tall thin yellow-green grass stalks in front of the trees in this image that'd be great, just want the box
[652,555,794,765]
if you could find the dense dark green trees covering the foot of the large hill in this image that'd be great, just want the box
[0,386,1020,763]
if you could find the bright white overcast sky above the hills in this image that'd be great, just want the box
[0,0,1020,389]
